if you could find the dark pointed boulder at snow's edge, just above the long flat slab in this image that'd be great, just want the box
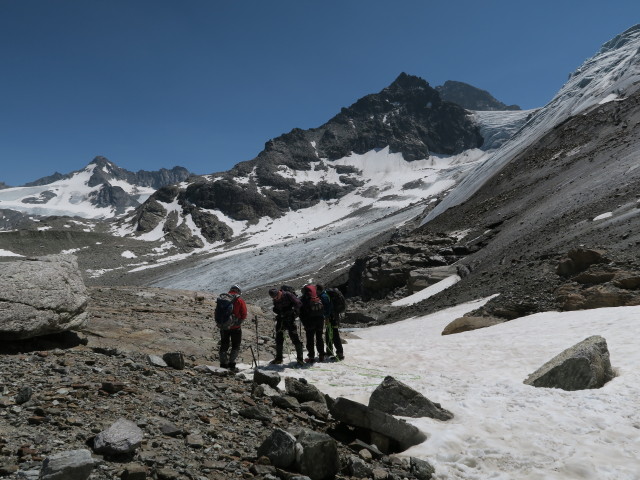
[369,377,453,420]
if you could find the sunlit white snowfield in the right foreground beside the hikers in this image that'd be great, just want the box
[282,301,640,480]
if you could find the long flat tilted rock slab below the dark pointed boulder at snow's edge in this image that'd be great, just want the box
[330,397,427,453]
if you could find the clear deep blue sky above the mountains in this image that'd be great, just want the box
[0,0,640,185]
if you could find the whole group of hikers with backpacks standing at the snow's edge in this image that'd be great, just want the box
[214,284,346,369]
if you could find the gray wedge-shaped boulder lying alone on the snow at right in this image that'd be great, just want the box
[524,335,614,391]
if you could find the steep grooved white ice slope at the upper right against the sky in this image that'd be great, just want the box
[422,25,640,224]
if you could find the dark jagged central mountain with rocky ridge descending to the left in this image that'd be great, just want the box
[127,73,483,247]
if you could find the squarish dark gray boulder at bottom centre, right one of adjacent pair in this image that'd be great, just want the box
[295,429,340,480]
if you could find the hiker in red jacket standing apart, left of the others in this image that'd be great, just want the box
[215,285,247,370]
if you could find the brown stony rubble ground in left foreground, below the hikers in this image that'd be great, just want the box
[0,287,430,480]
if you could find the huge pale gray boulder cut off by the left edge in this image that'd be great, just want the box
[0,255,89,341]
